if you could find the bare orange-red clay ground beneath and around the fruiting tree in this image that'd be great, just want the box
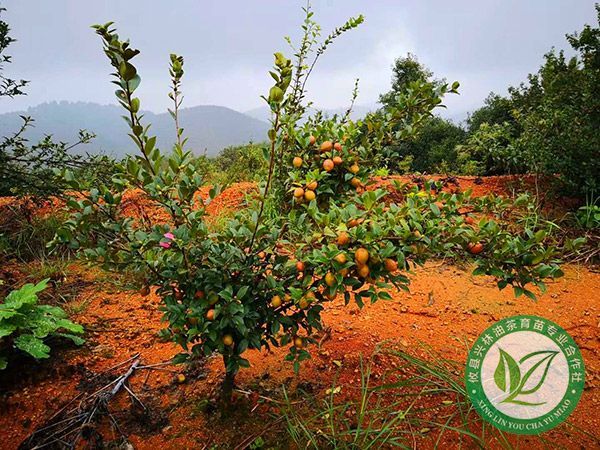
[0,177,600,449]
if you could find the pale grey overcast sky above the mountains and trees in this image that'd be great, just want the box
[0,0,595,117]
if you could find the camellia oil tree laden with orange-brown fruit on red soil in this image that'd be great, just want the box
[56,8,576,398]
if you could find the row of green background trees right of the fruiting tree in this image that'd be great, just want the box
[380,5,600,196]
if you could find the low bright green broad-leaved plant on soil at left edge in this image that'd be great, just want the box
[0,280,84,370]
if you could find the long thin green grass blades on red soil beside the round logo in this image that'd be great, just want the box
[281,344,597,449]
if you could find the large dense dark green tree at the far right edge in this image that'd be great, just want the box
[463,4,600,197]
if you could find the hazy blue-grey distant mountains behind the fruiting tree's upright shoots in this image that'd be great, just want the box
[0,102,269,157]
